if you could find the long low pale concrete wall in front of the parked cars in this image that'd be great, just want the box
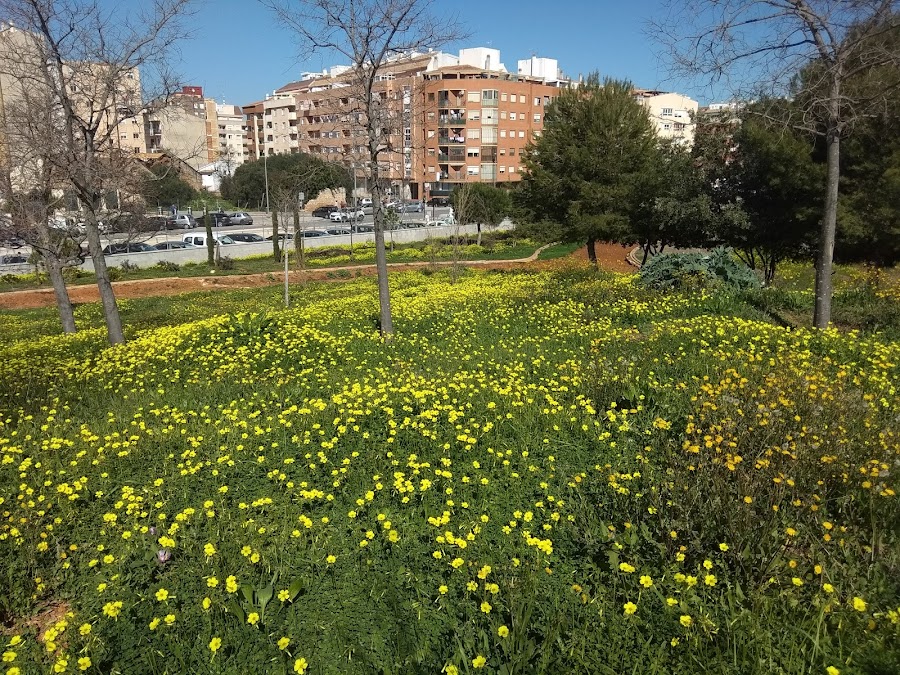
[81,221,512,272]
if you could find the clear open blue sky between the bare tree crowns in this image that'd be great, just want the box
[176,0,709,105]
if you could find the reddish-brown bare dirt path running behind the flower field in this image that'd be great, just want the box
[0,244,634,309]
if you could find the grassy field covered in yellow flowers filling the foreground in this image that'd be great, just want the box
[0,269,900,675]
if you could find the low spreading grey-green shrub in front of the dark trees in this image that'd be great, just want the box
[641,247,760,290]
